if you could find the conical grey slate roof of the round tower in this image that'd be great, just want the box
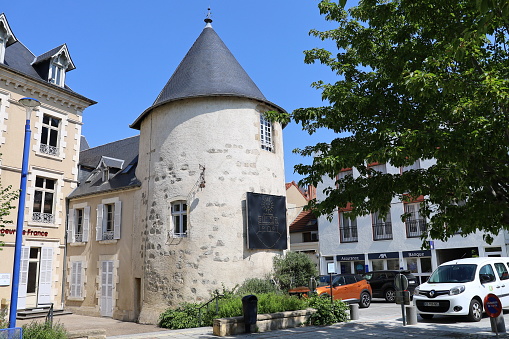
[131,22,284,129]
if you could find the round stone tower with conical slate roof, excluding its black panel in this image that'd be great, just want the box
[131,19,285,323]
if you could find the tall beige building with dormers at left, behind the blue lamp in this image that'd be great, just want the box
[0,14,95,316]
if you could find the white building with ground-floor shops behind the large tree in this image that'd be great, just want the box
[317,160,509,282]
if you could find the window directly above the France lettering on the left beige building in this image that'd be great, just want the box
[32,177,56,224]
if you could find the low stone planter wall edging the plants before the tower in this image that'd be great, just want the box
[213,308,316,337]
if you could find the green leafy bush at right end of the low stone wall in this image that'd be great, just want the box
[308,296,349,325]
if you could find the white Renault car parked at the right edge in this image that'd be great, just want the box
[414,257,509,321]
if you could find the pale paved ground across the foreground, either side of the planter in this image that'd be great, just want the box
[18,300,509,339]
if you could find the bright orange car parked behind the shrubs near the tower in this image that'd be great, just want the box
[288,274,372,308]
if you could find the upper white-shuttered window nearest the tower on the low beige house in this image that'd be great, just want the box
[96,199,122,241]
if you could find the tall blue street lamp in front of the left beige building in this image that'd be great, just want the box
[9,98,41,328]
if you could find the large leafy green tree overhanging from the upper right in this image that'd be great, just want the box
[268,0,509,243]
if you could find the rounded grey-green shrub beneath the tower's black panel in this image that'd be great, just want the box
[273,252,318,291]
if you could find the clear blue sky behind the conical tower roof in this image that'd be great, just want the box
[0,0,344,181]
